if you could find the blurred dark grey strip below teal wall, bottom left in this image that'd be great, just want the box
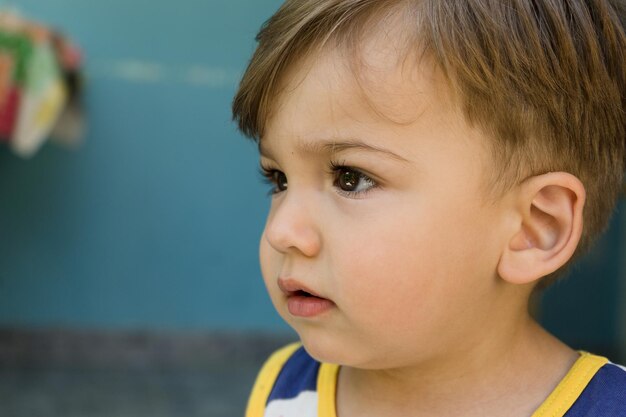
[0,329,287,417]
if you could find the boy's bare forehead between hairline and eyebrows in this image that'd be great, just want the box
[261,37,447,146]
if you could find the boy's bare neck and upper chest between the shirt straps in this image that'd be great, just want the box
[337,317,578,417]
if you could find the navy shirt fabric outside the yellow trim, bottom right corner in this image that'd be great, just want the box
[565,362,626,417]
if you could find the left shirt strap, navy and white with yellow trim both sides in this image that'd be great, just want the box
[246,343,338,417]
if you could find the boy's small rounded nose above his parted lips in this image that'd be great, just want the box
[264,193,322,257]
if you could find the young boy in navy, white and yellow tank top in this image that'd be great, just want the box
[233,0,626,417]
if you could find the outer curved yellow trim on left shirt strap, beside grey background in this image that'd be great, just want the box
[246,343,301,417]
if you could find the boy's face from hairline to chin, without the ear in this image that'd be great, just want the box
[260,38,510,369]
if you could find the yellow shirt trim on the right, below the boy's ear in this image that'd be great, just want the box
[532,352,609,417]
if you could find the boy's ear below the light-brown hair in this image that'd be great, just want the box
[498,172,585,284]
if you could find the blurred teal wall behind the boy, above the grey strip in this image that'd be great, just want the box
[0,0,626,354]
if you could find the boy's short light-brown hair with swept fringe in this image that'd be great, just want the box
[233,0,626,266]
